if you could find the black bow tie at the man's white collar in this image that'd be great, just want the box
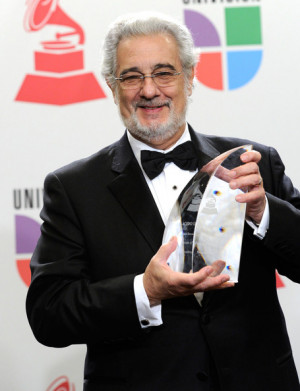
[141,141,198,180]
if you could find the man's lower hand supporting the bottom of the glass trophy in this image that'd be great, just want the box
[143,236,234,305]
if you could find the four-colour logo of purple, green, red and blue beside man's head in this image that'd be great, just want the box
[184,6,263,90]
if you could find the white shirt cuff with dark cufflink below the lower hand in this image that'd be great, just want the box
[133,274,163,328]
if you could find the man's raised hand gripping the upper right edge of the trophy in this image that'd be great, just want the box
[229,151,266,224]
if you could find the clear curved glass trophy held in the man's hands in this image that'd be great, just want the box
[163,145,252,282]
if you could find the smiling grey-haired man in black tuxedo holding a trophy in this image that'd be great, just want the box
[27,15,300,391]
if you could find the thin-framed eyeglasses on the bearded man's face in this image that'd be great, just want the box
[114,71,181,90]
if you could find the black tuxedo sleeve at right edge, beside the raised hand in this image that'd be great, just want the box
[261,148,300,282]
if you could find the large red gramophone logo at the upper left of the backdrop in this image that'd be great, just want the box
[16,0,106,105]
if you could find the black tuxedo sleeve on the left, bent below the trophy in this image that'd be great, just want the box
[26,174,141,347]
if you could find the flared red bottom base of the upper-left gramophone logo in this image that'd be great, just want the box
[15,72,106,106]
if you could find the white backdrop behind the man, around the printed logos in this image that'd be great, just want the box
[0,0,300,391]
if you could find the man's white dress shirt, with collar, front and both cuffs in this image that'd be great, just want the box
[127,125,269,328]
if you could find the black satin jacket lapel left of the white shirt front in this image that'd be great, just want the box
[108,135,165,252]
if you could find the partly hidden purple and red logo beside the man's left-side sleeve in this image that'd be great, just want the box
[15,215,40,286]
